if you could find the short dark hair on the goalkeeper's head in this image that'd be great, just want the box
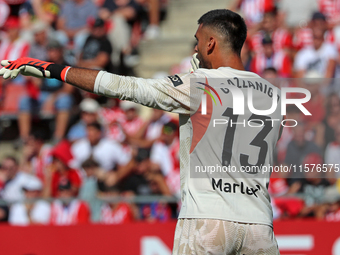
[198,9,247,55]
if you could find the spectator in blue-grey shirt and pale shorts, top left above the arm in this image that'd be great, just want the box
[57,0,98,53]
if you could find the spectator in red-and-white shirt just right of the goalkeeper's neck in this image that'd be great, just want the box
[250,36,292,78]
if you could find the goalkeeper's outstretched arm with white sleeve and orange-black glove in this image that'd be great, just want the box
[0,58,201,114]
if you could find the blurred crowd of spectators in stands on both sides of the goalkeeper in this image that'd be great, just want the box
[0,0,340,225]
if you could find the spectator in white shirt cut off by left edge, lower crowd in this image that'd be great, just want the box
[1,156,31,202]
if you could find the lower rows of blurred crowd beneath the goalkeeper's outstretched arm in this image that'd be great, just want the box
[0,98,180,225]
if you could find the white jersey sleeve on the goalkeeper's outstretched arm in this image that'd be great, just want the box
[94,71,203,114]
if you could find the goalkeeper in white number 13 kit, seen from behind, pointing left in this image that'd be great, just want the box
[0,9,281,255]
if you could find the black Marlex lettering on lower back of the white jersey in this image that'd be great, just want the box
[211,178,261,197]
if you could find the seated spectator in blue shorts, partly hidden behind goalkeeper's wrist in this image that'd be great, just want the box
[18,41,74,143]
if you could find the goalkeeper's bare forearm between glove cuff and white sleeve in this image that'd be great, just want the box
[66,67,99,92]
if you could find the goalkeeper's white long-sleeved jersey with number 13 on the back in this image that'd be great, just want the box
[94,67,282,226]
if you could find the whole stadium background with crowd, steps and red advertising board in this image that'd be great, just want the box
[0,0,340,255]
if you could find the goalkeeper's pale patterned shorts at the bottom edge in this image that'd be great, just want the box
[172,219,280,255]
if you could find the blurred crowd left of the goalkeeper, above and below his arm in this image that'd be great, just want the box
[0,0,175,225]
